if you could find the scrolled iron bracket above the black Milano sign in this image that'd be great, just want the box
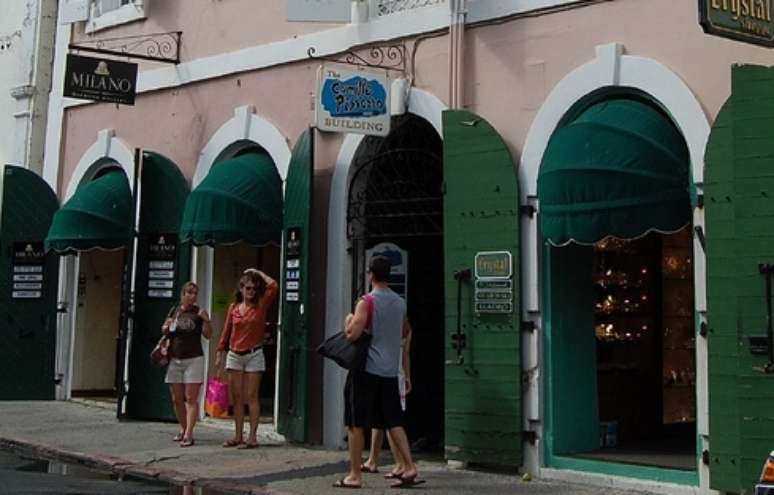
[68,31,183,64]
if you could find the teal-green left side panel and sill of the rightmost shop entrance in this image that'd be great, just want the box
[540,245,699,486]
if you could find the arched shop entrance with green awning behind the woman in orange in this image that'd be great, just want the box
[180,150,283,423]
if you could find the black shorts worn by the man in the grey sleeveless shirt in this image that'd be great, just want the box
[344,371,404,429]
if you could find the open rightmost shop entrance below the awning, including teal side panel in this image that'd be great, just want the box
[547,227,696,471]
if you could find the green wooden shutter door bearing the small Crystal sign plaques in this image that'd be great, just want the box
[443,110,522,466]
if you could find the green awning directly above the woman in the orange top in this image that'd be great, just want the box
[180,153,282,246]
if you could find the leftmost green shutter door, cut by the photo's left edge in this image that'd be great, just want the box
[0,169,59,400]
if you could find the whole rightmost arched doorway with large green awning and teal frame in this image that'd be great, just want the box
[538,94,698,482]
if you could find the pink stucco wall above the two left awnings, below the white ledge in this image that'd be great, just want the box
[59,63,317,191]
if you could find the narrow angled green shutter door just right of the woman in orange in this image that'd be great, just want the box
[278,130,314,442]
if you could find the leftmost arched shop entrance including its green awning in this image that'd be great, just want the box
[45,167,134,403]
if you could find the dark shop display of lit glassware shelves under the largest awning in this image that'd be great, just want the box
[593,227,696,458]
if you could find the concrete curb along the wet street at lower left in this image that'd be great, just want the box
[0,437,270,495]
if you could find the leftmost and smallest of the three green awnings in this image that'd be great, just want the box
[45,169,132,253]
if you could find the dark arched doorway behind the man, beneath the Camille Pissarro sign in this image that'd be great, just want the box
[347,114,444,452]
